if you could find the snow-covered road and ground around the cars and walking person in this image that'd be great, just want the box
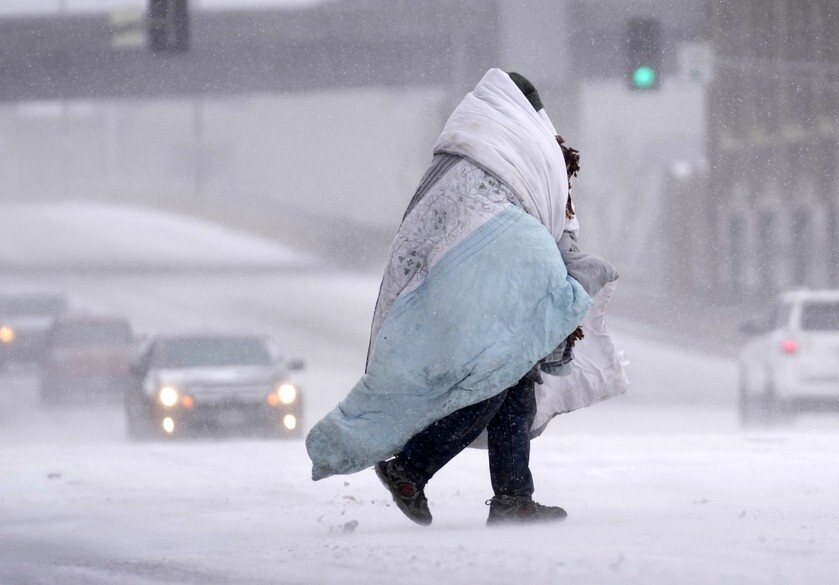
[0,203,839,585]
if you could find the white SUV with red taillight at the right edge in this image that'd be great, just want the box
[738,290,839,426]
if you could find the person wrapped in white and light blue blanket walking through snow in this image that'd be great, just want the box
[306,69,625,525]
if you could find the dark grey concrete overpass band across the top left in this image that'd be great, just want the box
[0,0,500,102]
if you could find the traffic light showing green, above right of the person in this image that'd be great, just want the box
[624,17,662,91]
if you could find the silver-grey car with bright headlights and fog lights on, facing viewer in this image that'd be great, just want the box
[125,334,304,440]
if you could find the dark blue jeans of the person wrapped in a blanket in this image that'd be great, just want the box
[396,378,536,496]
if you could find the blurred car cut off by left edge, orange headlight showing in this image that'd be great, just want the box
[0,292,68,368]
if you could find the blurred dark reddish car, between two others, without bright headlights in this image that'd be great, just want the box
[40,315,135,406]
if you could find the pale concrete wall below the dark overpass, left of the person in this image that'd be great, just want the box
[0,88,445,233]
